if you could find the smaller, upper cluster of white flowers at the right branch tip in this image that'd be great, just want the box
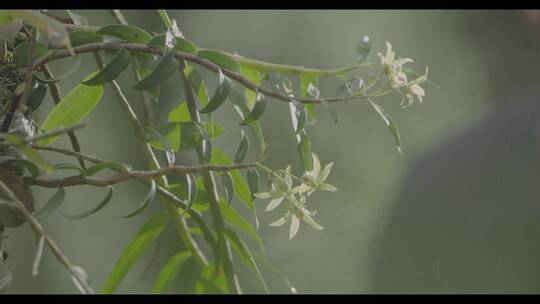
[377,41,428,107]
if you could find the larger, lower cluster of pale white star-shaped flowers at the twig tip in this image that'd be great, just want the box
[255,153,337,239]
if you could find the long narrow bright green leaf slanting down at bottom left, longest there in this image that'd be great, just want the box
[102,214,170,294]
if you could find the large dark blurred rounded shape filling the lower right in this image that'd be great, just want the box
[370,11,540,293]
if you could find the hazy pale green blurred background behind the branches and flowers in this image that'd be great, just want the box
[4,10,540,293]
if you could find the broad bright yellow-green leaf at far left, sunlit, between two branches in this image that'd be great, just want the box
[39,73,103,146]
